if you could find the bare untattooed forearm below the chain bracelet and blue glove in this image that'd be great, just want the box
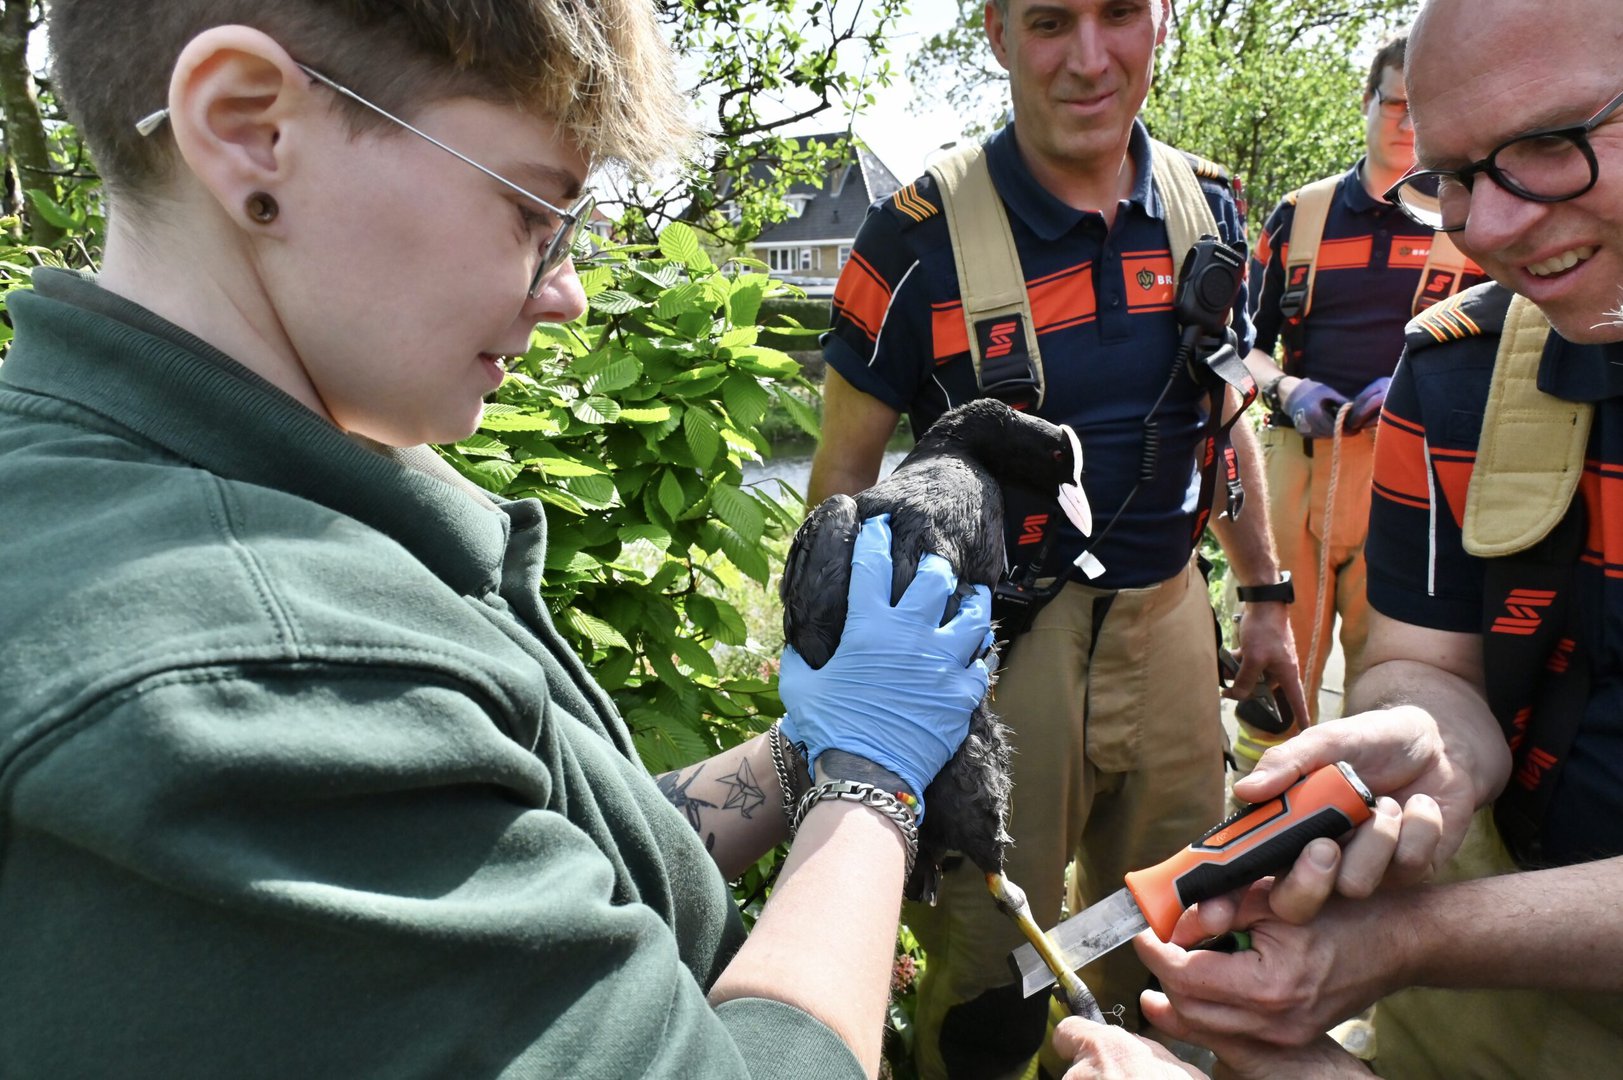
[709,802,906,1075]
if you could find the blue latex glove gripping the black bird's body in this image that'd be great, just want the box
[777,515,992,822]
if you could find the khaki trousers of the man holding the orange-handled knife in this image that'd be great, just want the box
[1375,810,1623,1080]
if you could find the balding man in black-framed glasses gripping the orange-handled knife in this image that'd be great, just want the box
[1058,0,1623,1078]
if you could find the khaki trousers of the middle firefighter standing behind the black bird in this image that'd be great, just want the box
[902,562,1224,1080]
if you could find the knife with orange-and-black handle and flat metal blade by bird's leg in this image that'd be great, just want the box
[1010,762,1375,997]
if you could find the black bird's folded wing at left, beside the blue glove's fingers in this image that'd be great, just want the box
[779,495,862,667]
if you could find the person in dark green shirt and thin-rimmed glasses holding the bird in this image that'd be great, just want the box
[0,0,990,1078]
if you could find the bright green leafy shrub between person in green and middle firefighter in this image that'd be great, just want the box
[441,222,816,771]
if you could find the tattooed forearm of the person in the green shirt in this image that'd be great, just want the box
[654,736,792,880]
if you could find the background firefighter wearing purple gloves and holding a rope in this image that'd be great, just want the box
[1235,34,1482,740]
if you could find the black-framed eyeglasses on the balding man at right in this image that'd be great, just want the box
[1386,87,1623,232]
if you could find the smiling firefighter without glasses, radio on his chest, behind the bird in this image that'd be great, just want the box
[810,0,1302,1077]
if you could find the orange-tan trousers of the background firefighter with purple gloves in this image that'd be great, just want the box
[1263,427,1375,723]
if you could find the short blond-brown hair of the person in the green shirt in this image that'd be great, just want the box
[47,0,691,197]
